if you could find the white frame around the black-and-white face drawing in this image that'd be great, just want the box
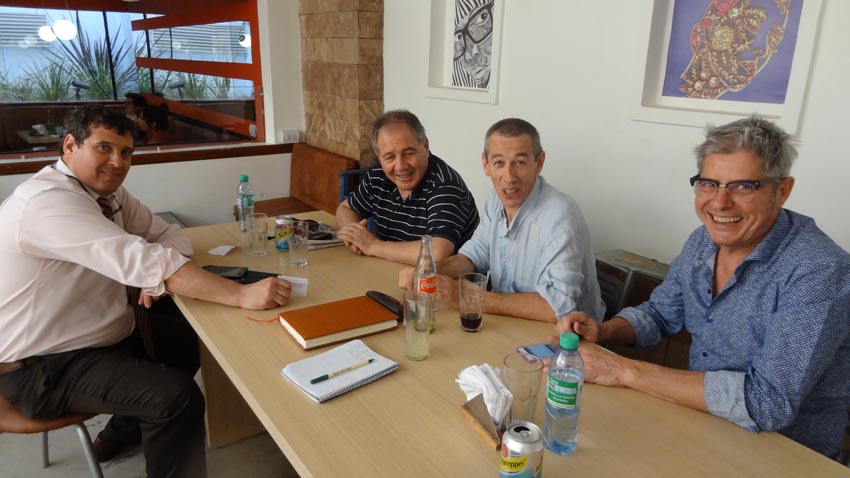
[425,0,504,104]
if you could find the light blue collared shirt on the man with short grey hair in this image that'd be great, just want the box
[458,176,605,321]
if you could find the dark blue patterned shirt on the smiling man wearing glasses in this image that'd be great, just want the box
[618,210,850,458]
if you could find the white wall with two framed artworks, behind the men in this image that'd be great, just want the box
[384,0,850,262]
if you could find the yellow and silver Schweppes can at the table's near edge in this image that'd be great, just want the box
[499,420,543,478]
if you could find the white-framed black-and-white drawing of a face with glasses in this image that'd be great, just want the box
[427,0,503,104]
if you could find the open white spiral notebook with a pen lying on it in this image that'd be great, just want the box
[280,340,398,403]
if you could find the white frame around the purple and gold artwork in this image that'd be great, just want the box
[632,0,823,134]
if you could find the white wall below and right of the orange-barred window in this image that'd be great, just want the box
[0,0,304,226]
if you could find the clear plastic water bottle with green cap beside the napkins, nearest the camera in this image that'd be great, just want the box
[543,332,584,455]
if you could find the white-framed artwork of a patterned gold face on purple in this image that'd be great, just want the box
[633,0,822,133]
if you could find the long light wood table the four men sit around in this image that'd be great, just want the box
[177,213,850,478]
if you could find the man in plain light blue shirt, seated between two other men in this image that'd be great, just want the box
[399,118,605,322]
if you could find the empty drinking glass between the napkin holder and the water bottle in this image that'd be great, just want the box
[502,352,543,424]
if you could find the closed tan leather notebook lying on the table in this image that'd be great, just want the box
[278,296,398,350]
